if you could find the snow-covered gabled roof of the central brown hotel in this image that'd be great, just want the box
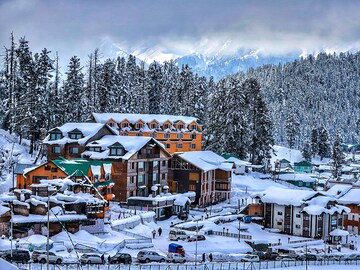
[83,135,170,160]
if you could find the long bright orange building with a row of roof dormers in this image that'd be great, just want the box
[91,113,203,154]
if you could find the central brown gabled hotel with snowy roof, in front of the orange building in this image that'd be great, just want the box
[82,135,171,202]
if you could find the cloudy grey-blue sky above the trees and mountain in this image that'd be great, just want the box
[0,0,360,65]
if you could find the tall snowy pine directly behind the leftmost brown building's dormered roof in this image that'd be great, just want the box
[63,56,84,122]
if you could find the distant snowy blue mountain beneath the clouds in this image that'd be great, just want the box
[175,50,301,80]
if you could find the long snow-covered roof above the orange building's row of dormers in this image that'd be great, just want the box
[92,113,198,125]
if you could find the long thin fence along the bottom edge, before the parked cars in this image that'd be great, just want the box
[8,260,360,270]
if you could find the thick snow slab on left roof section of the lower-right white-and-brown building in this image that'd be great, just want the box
[261,187,317,206]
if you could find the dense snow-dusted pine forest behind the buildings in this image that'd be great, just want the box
[0,35,360,163]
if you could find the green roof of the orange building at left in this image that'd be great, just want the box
[51,157,112,177]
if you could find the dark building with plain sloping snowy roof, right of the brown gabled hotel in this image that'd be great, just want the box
[169,151,232,207]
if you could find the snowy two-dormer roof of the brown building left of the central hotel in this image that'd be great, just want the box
[44,123,117,145]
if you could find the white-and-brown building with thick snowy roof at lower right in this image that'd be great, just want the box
[254,187,350,238]
